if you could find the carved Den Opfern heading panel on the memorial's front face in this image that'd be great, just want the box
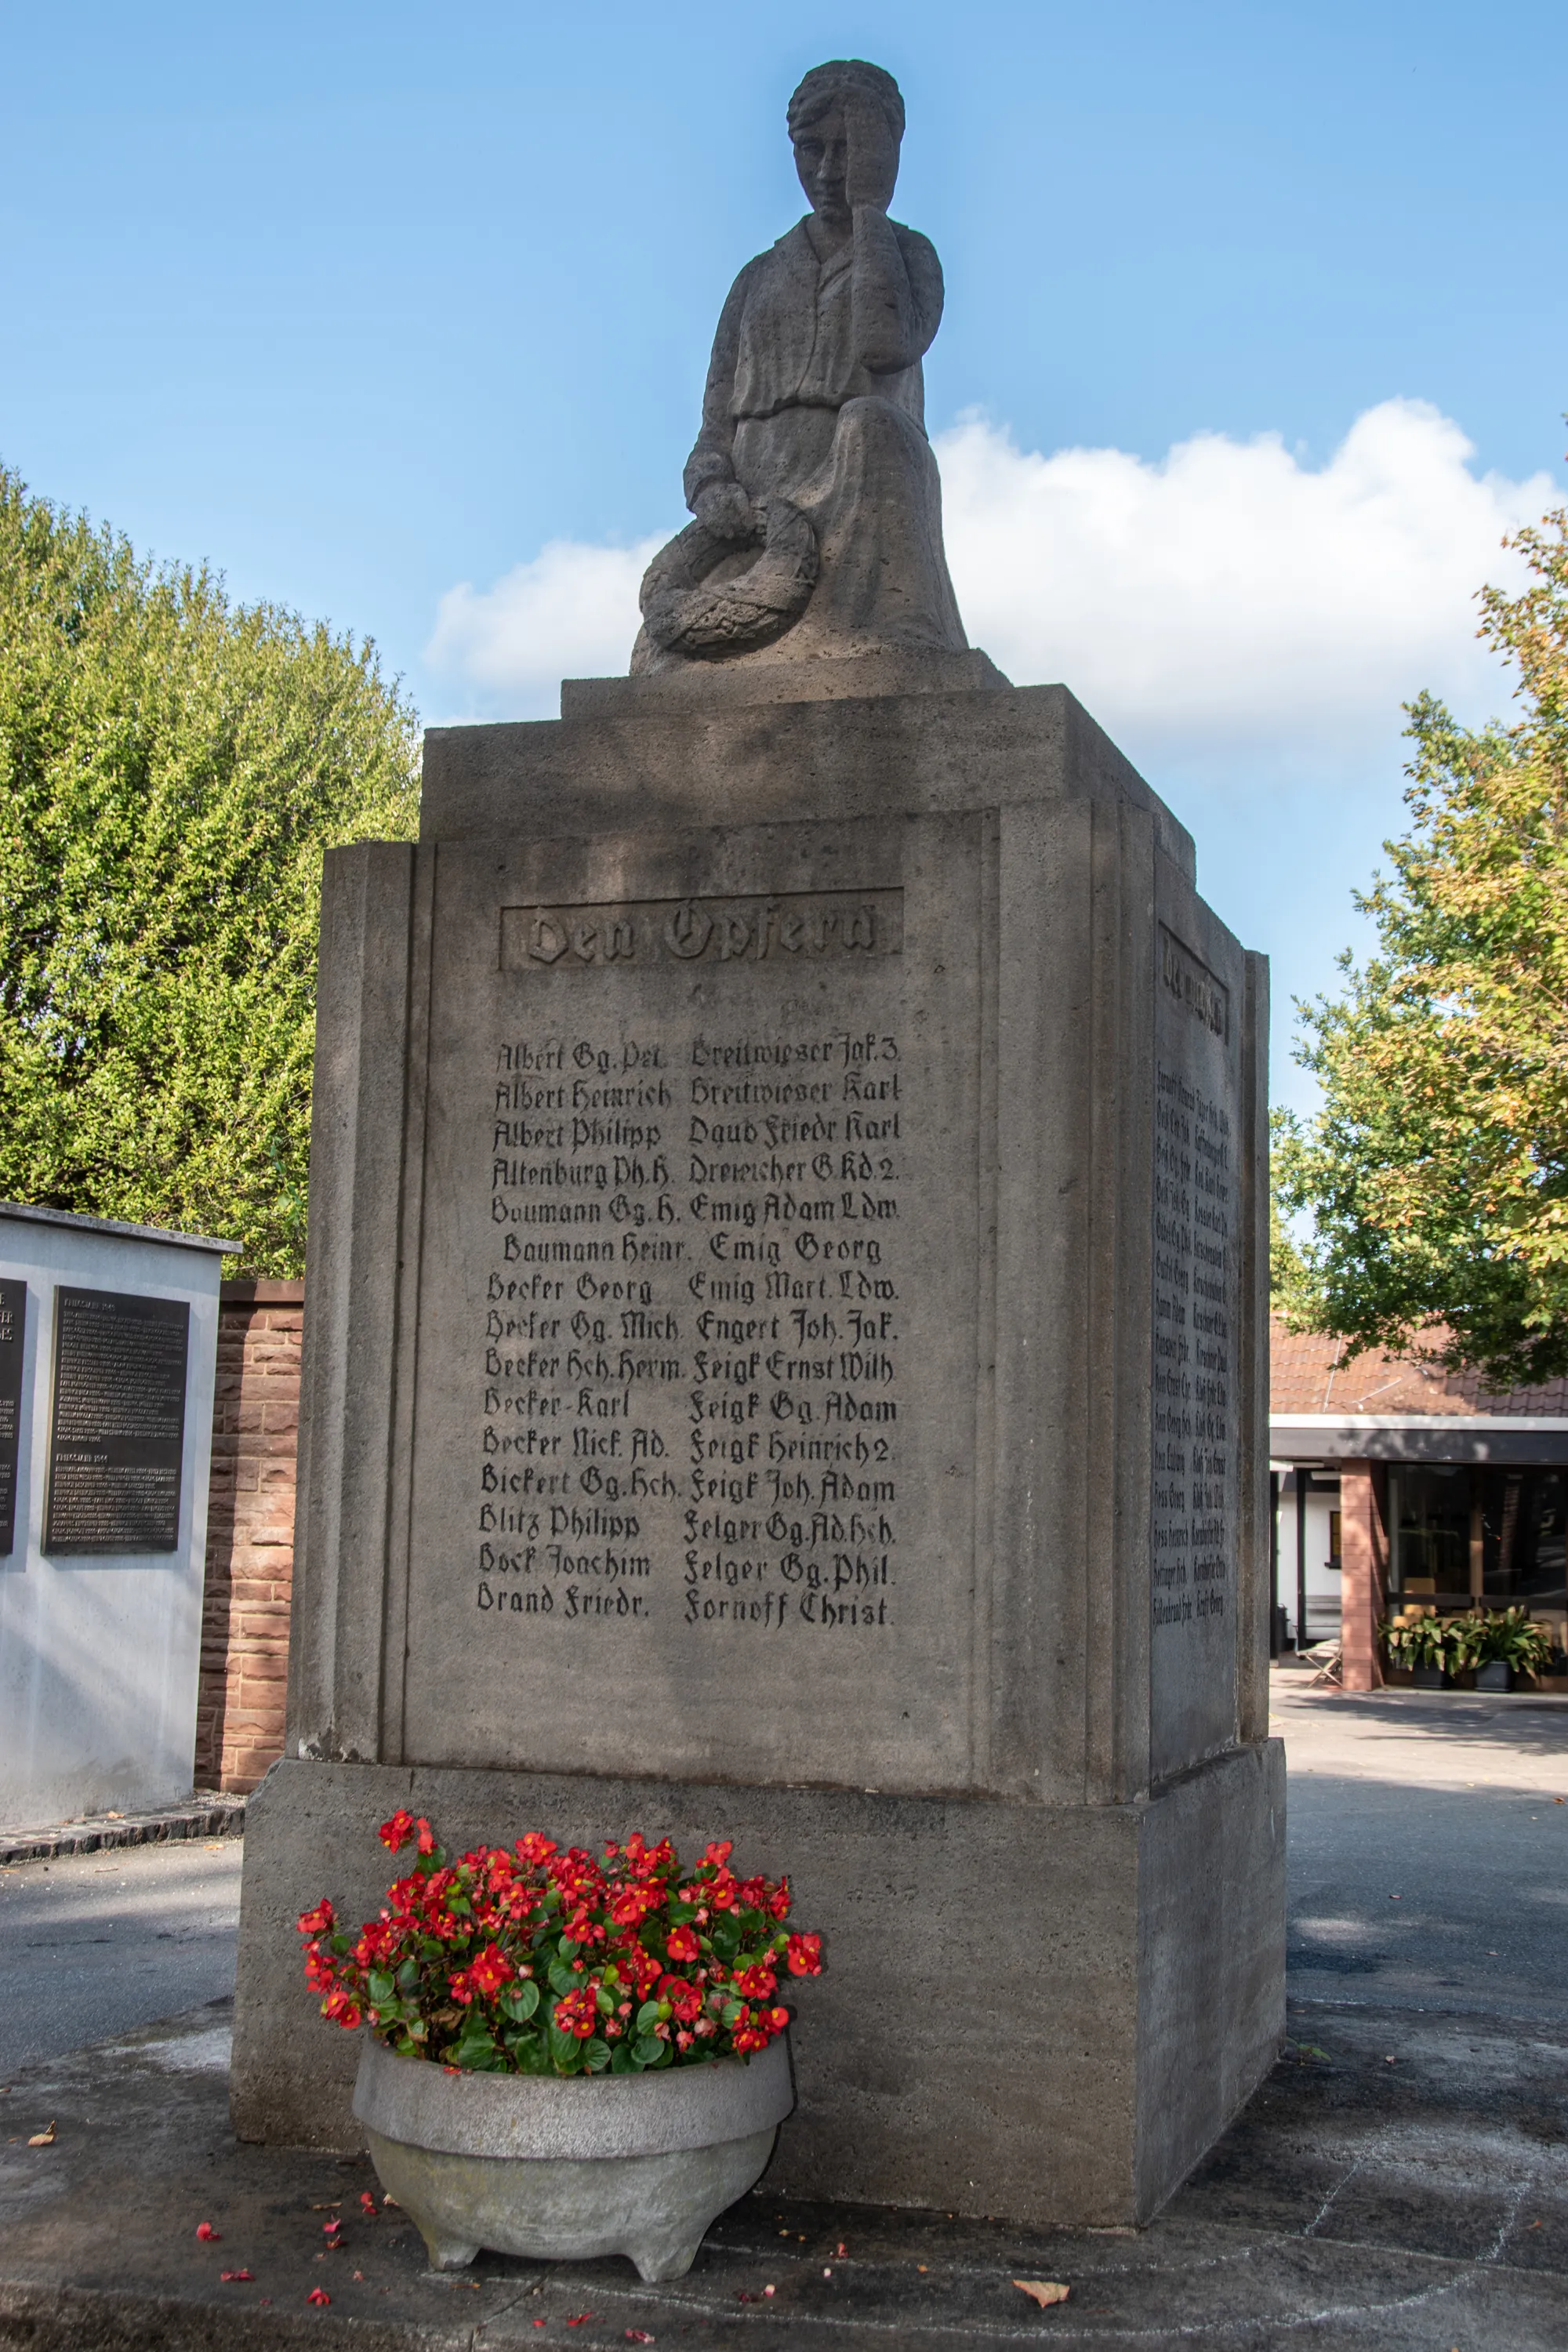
[501,889,902,971]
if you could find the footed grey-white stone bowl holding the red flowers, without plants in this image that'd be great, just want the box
[355,2034,794,2279]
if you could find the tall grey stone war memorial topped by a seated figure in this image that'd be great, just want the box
[233,61,1283,2225]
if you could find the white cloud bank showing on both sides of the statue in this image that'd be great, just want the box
[426,400,1559,783]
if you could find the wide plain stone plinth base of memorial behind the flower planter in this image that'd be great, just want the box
[233,1740,1286,2225]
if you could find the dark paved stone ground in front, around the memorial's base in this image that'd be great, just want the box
[0,2004,1568,2352]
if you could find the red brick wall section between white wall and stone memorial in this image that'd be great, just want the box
[195,1282,306,1790]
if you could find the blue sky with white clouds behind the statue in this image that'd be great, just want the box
[0,0,1568,1096]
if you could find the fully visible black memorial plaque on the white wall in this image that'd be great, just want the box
[45,1284,191,1552]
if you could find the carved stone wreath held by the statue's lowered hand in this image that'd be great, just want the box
[640,499,818,661]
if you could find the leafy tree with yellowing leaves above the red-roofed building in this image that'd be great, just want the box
[1279,487,1568,1385]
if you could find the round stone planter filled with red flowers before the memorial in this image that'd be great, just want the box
[299,1811,822,2279]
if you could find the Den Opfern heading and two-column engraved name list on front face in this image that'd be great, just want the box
[473,891,912,1644]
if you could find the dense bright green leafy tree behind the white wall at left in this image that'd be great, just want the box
[0,468,419,1275]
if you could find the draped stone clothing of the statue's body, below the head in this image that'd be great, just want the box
[687,212,968,661]
